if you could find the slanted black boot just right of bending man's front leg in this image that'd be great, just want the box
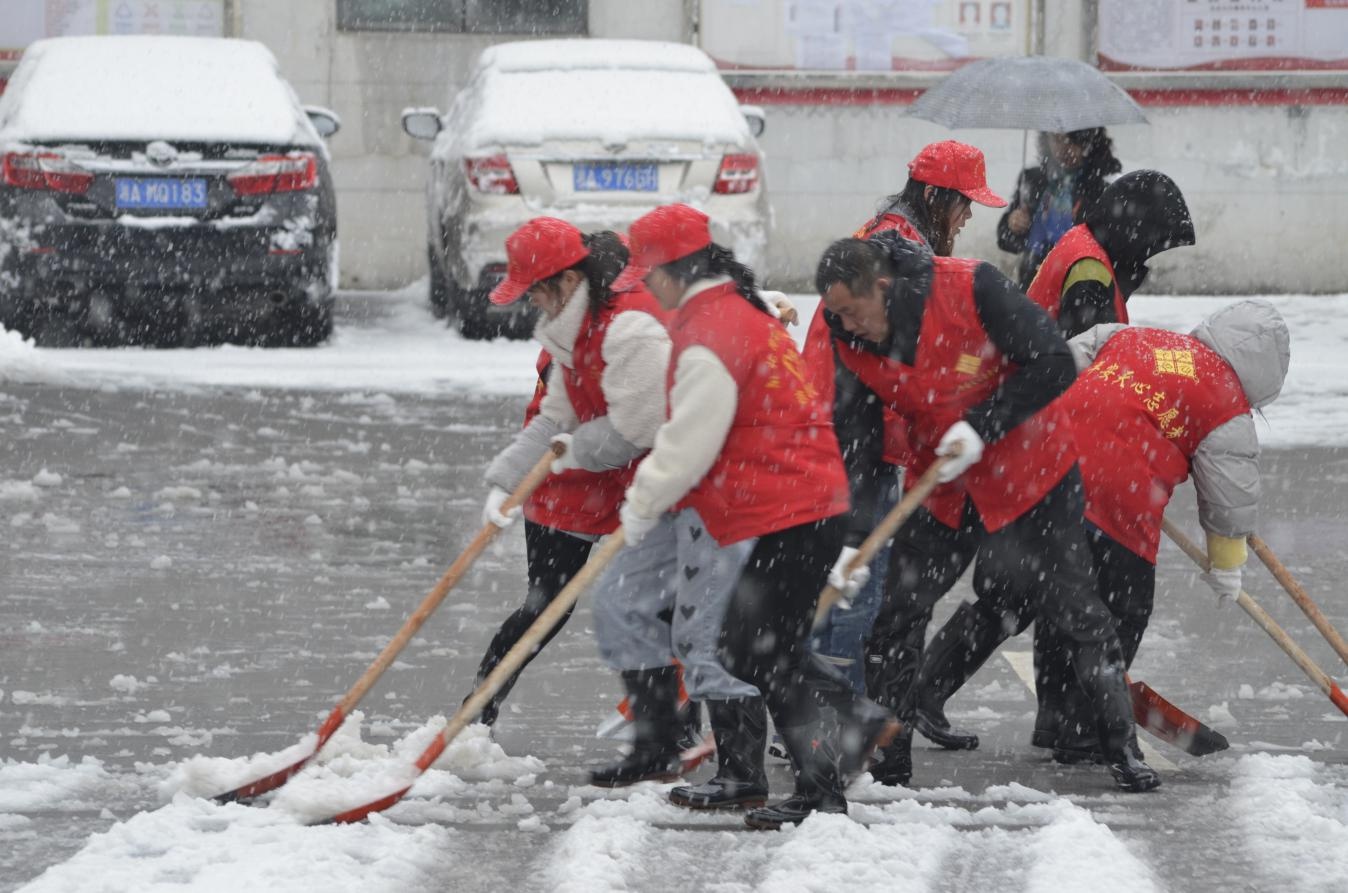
[900,602,1007,750]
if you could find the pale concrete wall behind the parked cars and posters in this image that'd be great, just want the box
[235,0,1348,293]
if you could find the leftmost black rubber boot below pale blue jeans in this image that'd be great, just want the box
[590,665,682,788]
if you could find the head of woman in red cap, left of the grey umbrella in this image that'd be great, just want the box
[852,139,1007,258]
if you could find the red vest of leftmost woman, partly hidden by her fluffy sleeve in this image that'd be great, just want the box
[524,286,667,536]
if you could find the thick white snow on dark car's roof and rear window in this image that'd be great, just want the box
[0,35,319,144]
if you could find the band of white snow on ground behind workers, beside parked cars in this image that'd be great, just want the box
[0,290,1348,450]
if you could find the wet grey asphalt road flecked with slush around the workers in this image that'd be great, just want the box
[0,295,1348,890]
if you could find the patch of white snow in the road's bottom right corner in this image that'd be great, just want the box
[1231,754,1348,893]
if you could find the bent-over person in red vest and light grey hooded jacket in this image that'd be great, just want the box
[1034,301,1290,762]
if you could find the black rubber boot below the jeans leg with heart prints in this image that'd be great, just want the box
[670,697,767,809]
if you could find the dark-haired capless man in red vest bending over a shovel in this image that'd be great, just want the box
[816,233,1159,790]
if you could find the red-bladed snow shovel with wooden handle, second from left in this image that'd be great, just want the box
[324,529,625,824]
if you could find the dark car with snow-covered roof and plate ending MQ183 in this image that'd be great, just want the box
[0,36,338,345]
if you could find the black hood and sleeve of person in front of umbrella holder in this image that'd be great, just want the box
[1058,170,1194,339]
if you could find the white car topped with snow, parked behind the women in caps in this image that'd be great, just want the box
[403,39,768,337]
